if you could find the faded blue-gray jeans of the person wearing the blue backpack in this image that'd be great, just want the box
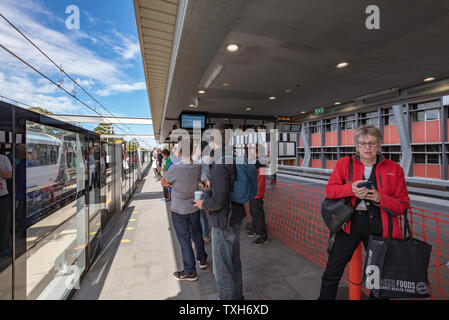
[211,222,243,300]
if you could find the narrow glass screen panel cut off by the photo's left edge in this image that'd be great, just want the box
[0,102,12,300]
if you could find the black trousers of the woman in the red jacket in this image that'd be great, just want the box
[318,211,380,300]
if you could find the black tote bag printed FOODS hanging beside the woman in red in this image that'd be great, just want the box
[362,208,432,299]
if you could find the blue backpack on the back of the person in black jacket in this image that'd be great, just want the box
[230,158,257,204]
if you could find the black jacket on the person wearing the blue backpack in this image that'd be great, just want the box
[203,151,245,229]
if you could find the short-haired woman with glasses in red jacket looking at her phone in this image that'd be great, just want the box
[318,125,410,300]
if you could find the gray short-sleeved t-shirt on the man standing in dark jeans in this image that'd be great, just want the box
[164,162,201,214]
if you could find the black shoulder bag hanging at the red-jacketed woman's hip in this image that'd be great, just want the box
[321,157,354,253]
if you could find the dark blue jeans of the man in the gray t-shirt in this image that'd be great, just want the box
[172,211,207,273]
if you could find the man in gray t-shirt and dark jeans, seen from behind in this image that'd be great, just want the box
[162,141,207,281]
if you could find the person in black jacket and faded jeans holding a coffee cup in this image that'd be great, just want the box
[195,123,245,300]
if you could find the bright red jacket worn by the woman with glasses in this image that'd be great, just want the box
[326,155,410,239]
